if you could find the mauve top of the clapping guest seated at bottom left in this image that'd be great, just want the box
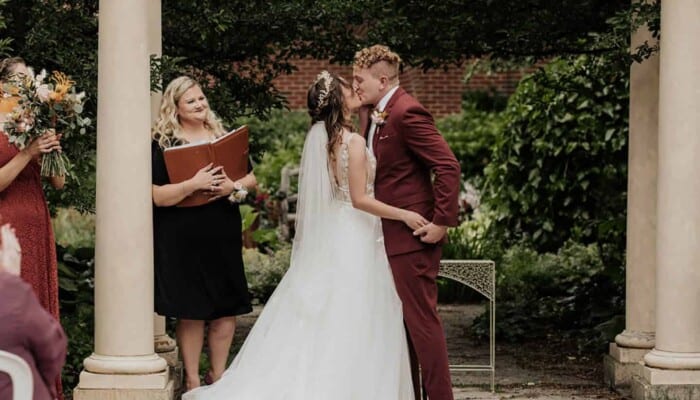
[0,271,67,400]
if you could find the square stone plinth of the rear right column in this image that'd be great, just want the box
[603,343,650,389]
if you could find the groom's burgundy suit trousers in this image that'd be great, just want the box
[389,245,453,400]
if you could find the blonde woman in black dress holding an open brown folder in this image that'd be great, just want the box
[152,76,256,390]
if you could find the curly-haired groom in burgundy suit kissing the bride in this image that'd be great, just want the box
[353,45,460,400]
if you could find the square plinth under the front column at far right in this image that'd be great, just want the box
[631,367,700,400]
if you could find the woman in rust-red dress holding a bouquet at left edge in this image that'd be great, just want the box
[0,57,65,398]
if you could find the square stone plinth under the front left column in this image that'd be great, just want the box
[73,371,175,400]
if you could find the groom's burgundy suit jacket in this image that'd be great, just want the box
[360,87,461,256]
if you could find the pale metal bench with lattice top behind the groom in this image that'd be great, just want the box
[438,260,496,393]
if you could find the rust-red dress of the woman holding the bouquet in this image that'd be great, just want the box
[0,131,61,398]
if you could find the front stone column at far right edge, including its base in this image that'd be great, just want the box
[632,0,700,399]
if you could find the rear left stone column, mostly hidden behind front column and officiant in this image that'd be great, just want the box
[147,1,178,367]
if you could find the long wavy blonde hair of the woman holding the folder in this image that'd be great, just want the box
[151,75,226,149]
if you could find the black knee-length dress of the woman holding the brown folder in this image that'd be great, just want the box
[151,141,252,320]
